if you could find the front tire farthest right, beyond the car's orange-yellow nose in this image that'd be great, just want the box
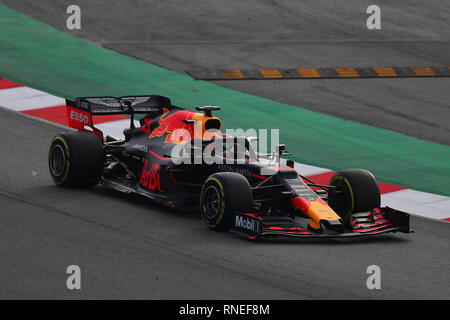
[328,169,381,222]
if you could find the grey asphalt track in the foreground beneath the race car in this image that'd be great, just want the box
[0,109,450,299]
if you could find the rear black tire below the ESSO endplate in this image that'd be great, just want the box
[48,131,104,187]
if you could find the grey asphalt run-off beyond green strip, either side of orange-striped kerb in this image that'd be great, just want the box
[2,0,450,145]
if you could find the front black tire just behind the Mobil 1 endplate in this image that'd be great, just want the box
[200,172,253,230]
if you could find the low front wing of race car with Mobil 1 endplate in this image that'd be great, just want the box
[231,207,410,239]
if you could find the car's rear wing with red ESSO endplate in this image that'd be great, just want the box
[66,95,175,141]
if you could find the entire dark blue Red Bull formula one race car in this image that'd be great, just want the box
[49,95,409,239]
